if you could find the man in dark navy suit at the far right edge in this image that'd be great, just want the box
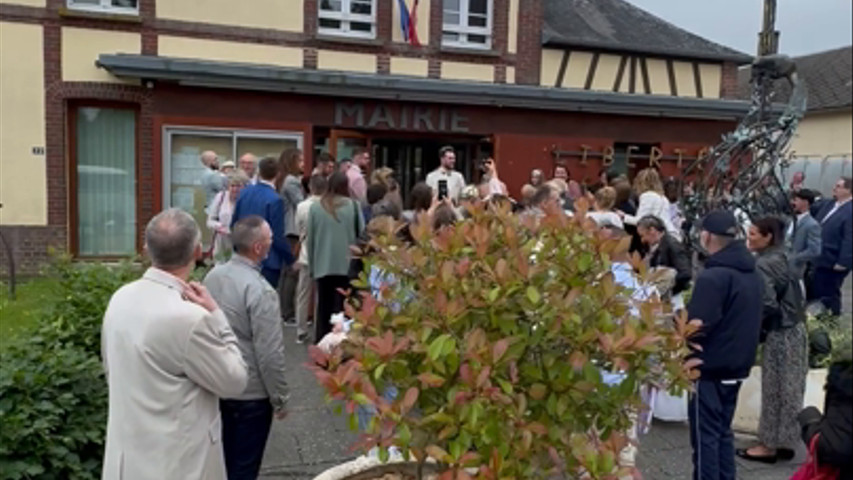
[812,177,853,315]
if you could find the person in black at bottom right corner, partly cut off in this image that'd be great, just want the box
[797,343,853,479]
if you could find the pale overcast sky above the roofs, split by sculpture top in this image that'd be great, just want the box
[628,0,853,56]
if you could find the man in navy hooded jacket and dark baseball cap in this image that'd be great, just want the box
[687,211,763,480]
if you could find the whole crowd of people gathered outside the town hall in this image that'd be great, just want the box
[103,147,853,480]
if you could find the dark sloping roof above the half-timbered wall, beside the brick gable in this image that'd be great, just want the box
[542,0,752,64]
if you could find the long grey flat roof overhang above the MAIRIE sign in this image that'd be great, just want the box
[97,54,749,120]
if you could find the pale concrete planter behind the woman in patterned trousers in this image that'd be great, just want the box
[732,367,827,434]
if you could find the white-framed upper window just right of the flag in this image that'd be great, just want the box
[441,0,492,50]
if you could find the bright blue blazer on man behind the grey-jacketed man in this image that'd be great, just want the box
[231,182,293,270]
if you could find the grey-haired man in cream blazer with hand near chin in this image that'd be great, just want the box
[101,209,247,480]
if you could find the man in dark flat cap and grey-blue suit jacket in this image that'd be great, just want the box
[787,189,821,280]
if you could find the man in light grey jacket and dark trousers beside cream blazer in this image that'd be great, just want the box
[204,215,288,480]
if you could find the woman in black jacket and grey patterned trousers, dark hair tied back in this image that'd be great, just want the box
[737,217,808,463]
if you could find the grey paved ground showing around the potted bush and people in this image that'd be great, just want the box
[262,328,805,480]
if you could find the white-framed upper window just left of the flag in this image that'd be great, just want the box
[317,0,376,38]
